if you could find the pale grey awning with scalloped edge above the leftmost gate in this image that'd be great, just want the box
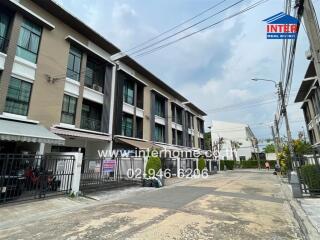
[0,119,64,145]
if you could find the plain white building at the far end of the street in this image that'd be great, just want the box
[211,121,257,161]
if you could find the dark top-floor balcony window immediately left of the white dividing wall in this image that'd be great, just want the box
[84,59,105,92]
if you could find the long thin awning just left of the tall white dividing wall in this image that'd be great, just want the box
[50,126,111,141]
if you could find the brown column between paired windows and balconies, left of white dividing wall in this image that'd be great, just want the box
[75,52,87,128]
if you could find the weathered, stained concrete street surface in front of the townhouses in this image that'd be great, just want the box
[0,171,302,240]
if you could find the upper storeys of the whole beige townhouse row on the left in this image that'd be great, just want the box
[0,0,205,157]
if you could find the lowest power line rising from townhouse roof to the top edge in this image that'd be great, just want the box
[136,0,269,58]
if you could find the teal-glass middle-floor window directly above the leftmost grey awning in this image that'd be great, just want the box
[5,77,32,116]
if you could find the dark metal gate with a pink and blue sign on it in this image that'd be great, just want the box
[80,157,143,194]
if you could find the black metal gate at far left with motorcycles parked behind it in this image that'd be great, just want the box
[0,154,75,204]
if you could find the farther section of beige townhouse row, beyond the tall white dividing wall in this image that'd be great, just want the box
[113,62,205,150]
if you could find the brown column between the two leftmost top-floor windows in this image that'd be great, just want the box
[0,12,23,114]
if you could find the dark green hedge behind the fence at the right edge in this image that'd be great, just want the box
[301,165,320,194]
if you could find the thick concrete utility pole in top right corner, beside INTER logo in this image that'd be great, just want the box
[299,0,320,80]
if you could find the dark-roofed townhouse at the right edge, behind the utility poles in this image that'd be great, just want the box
[295,61,320,150]
